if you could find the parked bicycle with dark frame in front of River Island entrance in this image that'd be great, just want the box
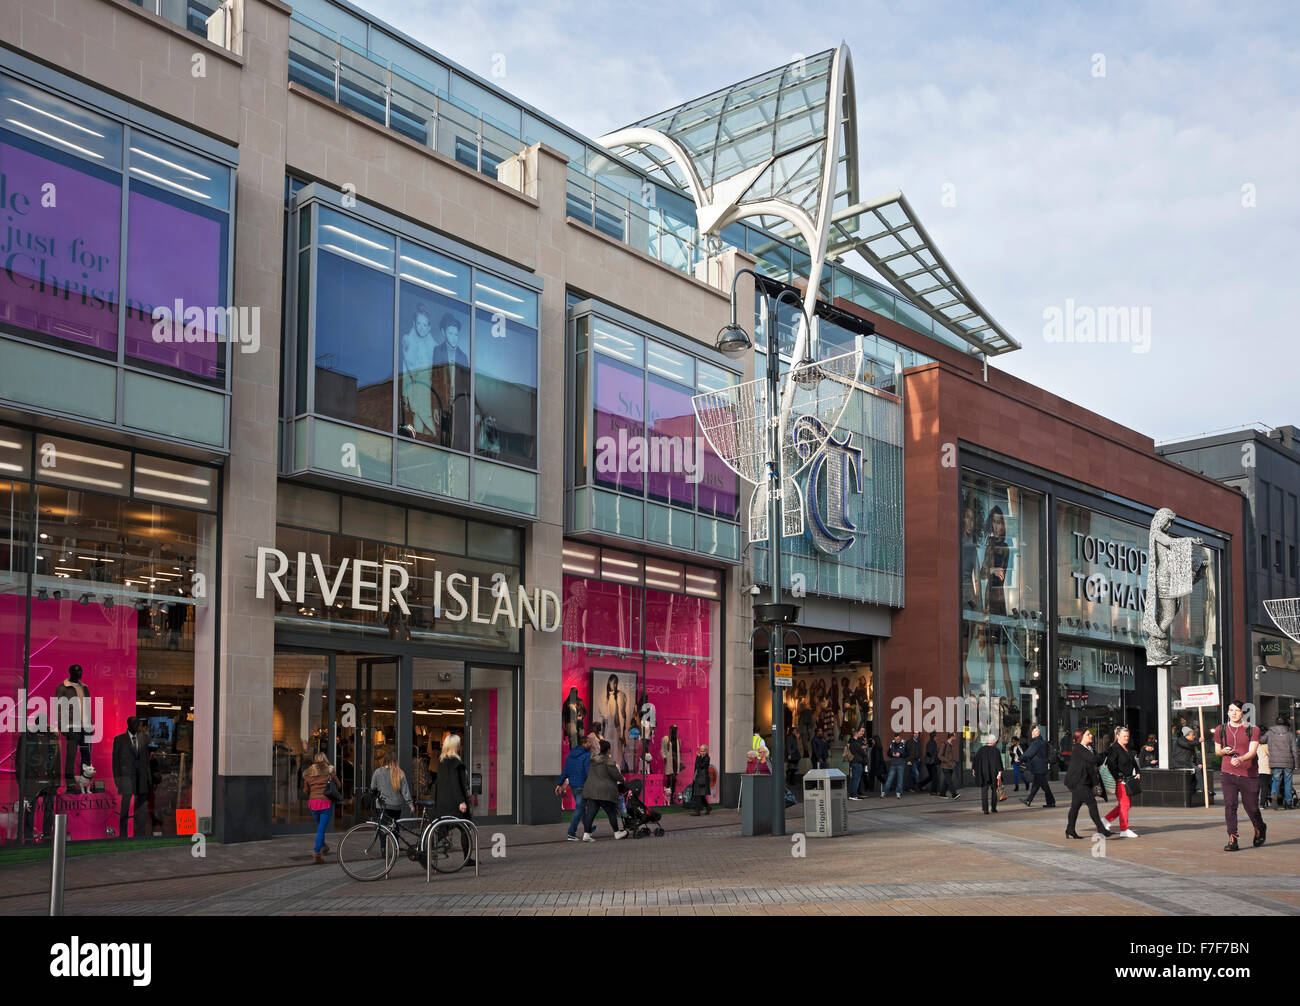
[338,790,469,881]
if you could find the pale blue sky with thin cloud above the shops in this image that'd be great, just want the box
[360,0,1300,441]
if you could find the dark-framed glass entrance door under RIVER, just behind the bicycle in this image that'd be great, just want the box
[333,654,402,828]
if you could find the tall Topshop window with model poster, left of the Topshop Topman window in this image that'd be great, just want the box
[957,472,1048,766]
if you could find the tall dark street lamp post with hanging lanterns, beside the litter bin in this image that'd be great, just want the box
[715,269,815,834]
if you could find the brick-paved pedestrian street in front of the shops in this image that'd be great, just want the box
[0,790,1300,915]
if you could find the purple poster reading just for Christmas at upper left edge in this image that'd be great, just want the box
[0,143,122,354]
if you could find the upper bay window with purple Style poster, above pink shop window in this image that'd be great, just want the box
[572,313,740,558]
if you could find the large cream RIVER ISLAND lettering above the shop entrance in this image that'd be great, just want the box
[257,546,560,632]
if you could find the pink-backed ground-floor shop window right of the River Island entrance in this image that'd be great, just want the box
[558,542,722,808]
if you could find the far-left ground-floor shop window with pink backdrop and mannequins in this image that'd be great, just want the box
[0,429,218,845]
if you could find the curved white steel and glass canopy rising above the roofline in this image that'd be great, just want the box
[599,43,1019,359]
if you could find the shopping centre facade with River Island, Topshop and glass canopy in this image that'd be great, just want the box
[0,0,1251,844]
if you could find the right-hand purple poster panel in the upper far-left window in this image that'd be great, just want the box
[126,186,226,380]
